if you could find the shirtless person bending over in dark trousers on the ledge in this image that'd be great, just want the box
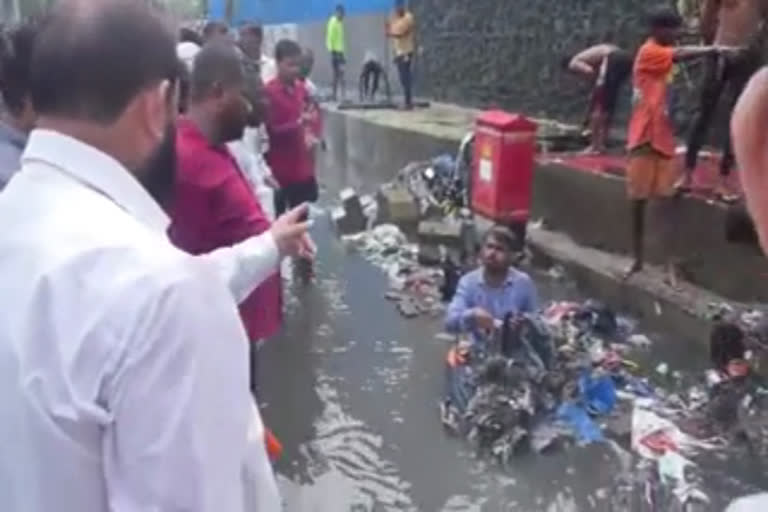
[563,44,632,153]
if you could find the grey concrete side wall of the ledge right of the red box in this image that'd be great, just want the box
[533,163,768,302]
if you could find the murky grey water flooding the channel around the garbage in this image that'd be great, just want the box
[261,134,768,512]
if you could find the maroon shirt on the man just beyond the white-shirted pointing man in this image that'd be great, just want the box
[169,119,282,341]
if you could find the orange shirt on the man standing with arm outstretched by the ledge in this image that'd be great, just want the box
[627,38,675,157]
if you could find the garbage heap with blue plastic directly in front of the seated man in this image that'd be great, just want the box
[443,301,650,458]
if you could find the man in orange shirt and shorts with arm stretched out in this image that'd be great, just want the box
[626,9,726,286]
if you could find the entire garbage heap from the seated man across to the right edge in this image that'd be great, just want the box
[441,301,768,511]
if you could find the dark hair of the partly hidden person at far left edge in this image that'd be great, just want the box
[0,20,38,115]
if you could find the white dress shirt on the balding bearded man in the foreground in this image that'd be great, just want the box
[0,130,280,512]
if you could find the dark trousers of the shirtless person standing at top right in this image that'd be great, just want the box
[685,52,761,176]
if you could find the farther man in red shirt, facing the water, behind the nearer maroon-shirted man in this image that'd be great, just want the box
[265,39,318,215]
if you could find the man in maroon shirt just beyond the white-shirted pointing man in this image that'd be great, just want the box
[169,43,282,390]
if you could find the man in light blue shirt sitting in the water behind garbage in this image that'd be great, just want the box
[445,226,538,343]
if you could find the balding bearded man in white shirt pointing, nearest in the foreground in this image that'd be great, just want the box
[0,0,306,512]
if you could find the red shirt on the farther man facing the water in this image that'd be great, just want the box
[264,78,315,187]
